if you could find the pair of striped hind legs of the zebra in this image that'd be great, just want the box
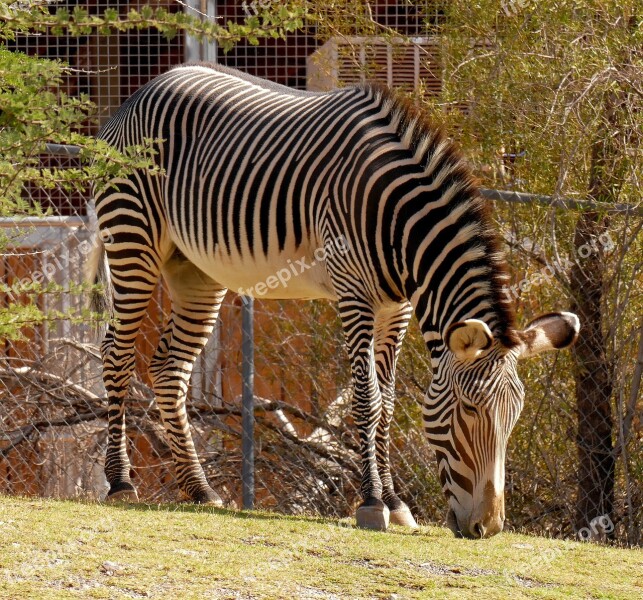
[96,174,225,503]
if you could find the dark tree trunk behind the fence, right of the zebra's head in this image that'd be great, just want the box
[570,92,622,538]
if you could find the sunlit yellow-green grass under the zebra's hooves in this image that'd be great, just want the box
[0,496,643,600]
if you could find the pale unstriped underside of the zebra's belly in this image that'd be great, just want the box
[179,245,337,300]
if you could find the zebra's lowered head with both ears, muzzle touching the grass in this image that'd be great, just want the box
[424,313,580,538]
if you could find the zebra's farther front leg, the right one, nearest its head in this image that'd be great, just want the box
[375,303,417,527]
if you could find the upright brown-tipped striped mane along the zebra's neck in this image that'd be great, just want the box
[361,82,520,348]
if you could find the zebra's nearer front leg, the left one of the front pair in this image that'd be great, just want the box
[339,300,389,531]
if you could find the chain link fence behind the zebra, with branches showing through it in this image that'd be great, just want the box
[0,3,643,544]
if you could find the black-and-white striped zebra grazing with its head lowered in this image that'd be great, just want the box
[92,63,579,538]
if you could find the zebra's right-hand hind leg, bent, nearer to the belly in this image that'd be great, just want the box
[149,252,226,506]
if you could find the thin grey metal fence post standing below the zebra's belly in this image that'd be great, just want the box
[241,296,255,509]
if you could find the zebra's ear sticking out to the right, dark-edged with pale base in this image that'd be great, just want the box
[517,312,580,358]
